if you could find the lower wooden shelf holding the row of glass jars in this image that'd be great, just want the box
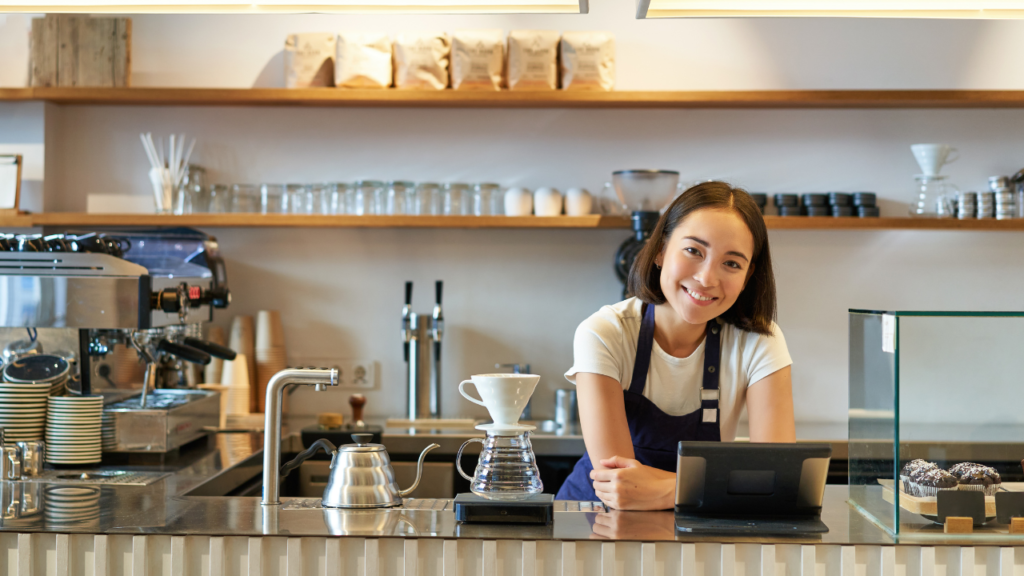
[6,212,1024,232]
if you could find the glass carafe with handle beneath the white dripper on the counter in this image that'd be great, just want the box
[456,426,544,500]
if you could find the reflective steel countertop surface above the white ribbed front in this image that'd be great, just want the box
[0,425,1007,545]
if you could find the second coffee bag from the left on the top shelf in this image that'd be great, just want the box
[334,32,391,88]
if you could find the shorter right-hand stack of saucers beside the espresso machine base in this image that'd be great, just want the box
[46,396,103,464]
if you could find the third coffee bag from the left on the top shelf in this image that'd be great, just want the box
[394,32,452,90]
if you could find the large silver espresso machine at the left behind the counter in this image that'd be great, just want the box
[0,229,234,452]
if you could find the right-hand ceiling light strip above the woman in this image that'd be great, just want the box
[637,0,1024,19]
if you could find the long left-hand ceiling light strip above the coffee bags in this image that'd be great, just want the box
[0,0,590,14]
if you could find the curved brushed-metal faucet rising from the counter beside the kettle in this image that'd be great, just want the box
[260,368,338,506]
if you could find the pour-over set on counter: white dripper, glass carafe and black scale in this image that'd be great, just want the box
[455,374,554,525]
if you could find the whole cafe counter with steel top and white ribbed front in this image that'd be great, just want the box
[0,434,1024,576]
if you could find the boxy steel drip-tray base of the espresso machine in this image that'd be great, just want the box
[102,389,220,452]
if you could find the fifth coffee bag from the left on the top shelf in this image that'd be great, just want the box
[508,30,558,90]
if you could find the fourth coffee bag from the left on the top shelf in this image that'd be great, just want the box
[452,30,505,90]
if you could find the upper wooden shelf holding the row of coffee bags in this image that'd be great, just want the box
[9,88,1024,109]
